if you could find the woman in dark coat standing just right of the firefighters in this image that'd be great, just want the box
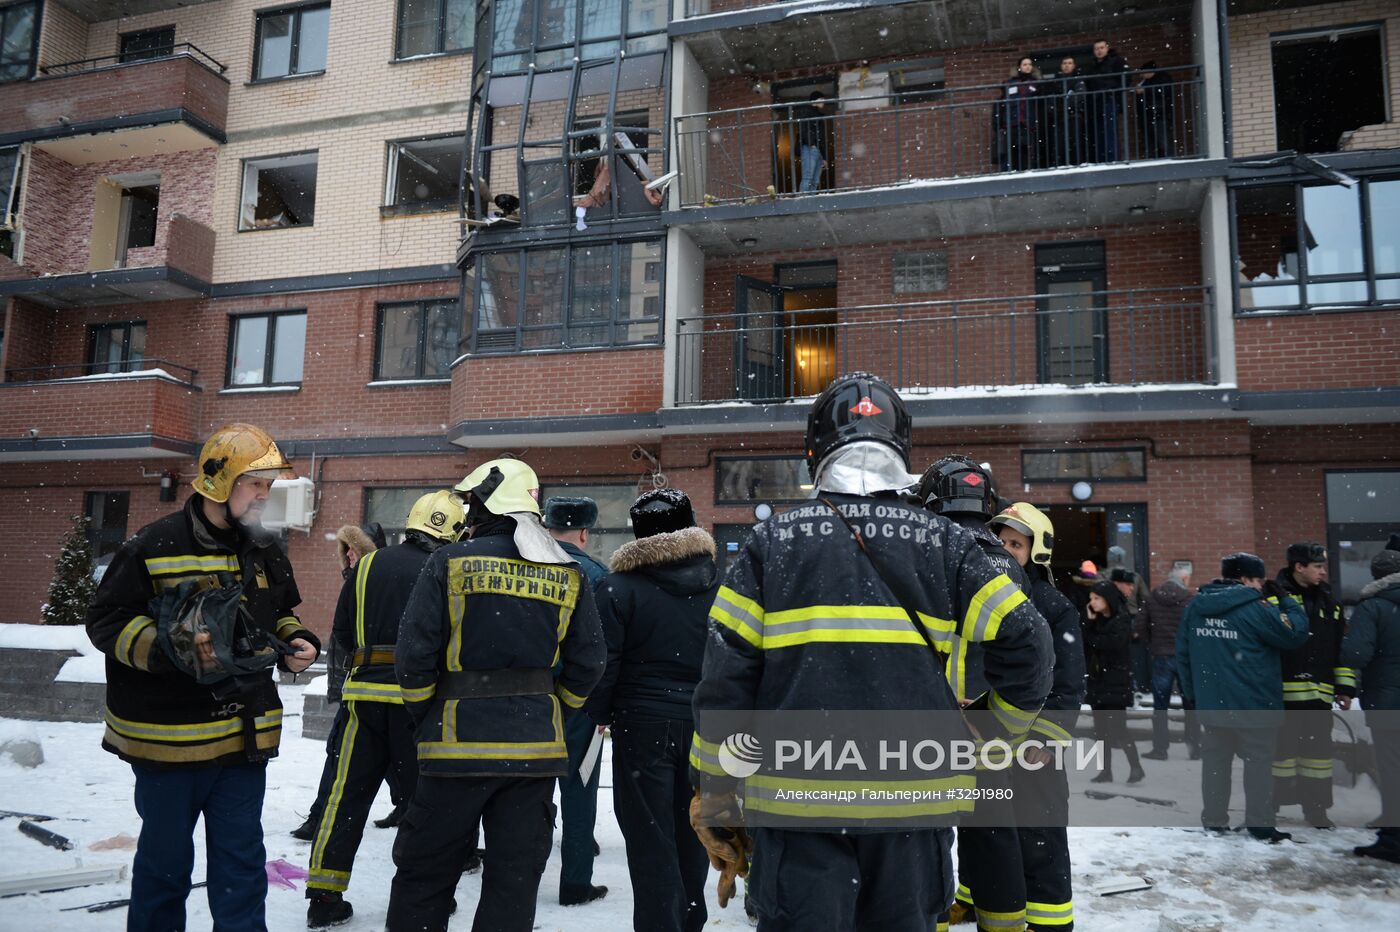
[1084,581,1144,784]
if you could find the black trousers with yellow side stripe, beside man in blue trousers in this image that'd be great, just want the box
[307,700,419,896]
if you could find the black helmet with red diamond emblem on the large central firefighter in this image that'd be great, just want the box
[805,372,914,481]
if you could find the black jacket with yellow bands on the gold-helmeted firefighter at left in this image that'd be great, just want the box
[87,495,321,768]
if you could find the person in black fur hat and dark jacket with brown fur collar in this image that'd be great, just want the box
[584,488,720,932]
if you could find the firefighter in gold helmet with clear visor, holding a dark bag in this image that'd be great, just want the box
[87,424,321,932]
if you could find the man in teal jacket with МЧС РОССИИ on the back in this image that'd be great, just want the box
[1176,553,1308,844]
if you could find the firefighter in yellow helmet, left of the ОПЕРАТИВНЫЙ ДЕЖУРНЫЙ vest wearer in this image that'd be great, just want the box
[307,490,466,929]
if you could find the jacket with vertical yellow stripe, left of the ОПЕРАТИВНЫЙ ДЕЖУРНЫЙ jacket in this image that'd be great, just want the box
[330,532,433,704]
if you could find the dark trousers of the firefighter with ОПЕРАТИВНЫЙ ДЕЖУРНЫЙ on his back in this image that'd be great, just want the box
[385,774,554,932]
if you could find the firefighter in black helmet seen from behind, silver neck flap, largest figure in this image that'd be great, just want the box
[690,374,1050,932]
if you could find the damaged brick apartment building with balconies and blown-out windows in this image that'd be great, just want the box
[0,0,1400,630]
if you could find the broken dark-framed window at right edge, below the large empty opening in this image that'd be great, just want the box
[1229,169,1400,318]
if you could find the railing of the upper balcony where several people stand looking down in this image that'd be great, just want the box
[676,66,1205,207]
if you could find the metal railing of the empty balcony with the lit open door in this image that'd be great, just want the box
[676,287,1215,404]
